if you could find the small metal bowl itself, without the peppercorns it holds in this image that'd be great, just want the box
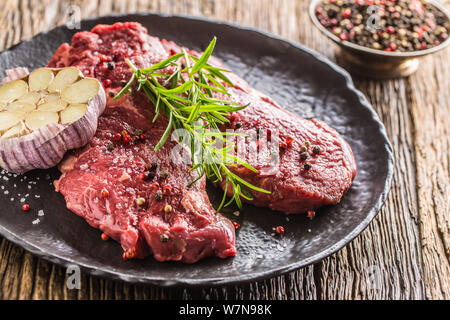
[309,0,450,79]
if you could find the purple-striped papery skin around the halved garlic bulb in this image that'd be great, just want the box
[0,68,106,173]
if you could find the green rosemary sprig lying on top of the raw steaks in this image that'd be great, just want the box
[114,37,270,211]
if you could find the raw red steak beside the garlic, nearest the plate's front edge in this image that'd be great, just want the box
[49,23,236,263]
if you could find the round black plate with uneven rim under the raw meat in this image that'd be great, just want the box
[0,14,393,286]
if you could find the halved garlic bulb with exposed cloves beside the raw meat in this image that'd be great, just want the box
[0,67,106,173]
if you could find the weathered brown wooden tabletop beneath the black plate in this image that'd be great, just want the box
[0,0,450,299]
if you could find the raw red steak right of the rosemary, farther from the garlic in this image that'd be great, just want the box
[161,39,356,213]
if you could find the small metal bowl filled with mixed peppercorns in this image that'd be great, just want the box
[309,0,450,79]
